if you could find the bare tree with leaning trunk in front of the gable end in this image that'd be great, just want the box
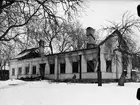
[100,12,140,85]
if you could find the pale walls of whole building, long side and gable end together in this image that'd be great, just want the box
[10,41,131,79]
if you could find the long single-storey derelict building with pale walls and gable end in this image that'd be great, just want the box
[10,30,132,80]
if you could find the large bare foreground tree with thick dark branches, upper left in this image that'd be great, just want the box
[0,0,83,71]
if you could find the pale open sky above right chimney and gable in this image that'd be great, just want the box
[78,0,140,46]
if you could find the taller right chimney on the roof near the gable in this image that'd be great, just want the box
[86,27,95,48]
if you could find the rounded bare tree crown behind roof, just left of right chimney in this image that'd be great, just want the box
[58,21,87,52]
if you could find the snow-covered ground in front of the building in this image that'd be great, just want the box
[0,80,140,105]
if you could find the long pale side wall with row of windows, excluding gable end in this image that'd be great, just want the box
[10,49,97,79]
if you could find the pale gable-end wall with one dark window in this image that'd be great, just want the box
[100,36,122,79]
